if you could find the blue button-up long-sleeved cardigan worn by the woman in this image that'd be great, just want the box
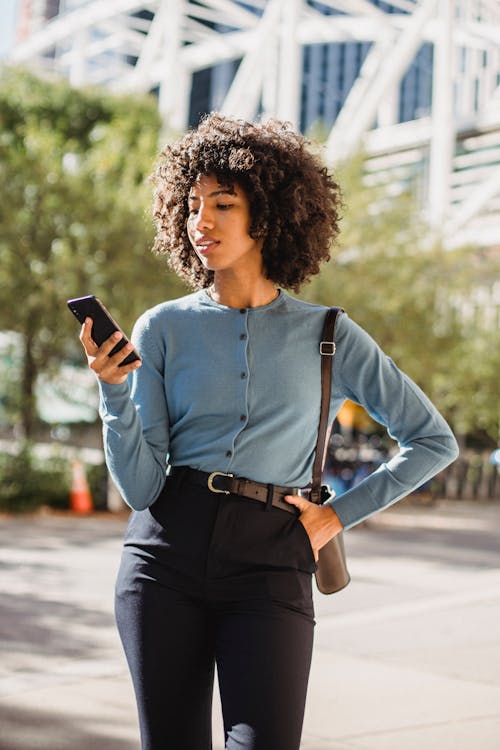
[96,291,458,528]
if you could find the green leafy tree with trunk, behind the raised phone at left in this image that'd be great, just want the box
[0,69,183,437]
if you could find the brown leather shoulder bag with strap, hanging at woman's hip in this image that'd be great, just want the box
[309,307,351,594]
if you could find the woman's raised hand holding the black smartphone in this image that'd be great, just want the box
[80,318,141,385]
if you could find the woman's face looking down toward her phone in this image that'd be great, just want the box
[187,175,263,280]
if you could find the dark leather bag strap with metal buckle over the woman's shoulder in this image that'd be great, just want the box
[310,307,344,503]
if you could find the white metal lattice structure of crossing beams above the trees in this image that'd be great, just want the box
[6,0,500,246]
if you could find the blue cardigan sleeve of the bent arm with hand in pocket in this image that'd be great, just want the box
[329,315,458,529]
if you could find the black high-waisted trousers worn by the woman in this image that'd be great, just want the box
[116,478,316,750]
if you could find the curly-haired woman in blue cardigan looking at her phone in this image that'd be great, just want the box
[81,114,457,750]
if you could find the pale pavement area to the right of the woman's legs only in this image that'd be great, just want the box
[304,503,500,750]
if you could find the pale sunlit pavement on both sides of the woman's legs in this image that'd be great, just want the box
[0,501,500,750]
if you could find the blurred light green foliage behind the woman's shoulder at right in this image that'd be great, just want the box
[302,156,500,441]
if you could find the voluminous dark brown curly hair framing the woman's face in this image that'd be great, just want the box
[152,113,341,291]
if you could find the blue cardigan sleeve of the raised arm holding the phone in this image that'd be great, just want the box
[99,319,169,510]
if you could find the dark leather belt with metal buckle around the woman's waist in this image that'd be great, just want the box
[170,466,302,515]
